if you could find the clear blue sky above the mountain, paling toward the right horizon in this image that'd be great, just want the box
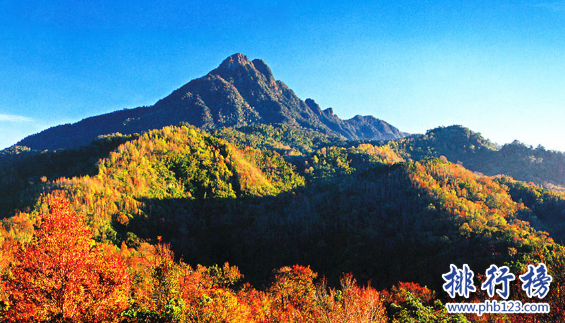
[0,0,565,151]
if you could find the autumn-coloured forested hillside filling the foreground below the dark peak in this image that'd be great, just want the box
[0,125,565,322]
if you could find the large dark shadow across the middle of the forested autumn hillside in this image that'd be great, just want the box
[121,170,488,288]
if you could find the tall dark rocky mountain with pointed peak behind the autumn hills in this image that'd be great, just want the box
[17,54,406,150]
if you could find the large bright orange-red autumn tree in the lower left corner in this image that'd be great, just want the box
[3,194,130,322]
